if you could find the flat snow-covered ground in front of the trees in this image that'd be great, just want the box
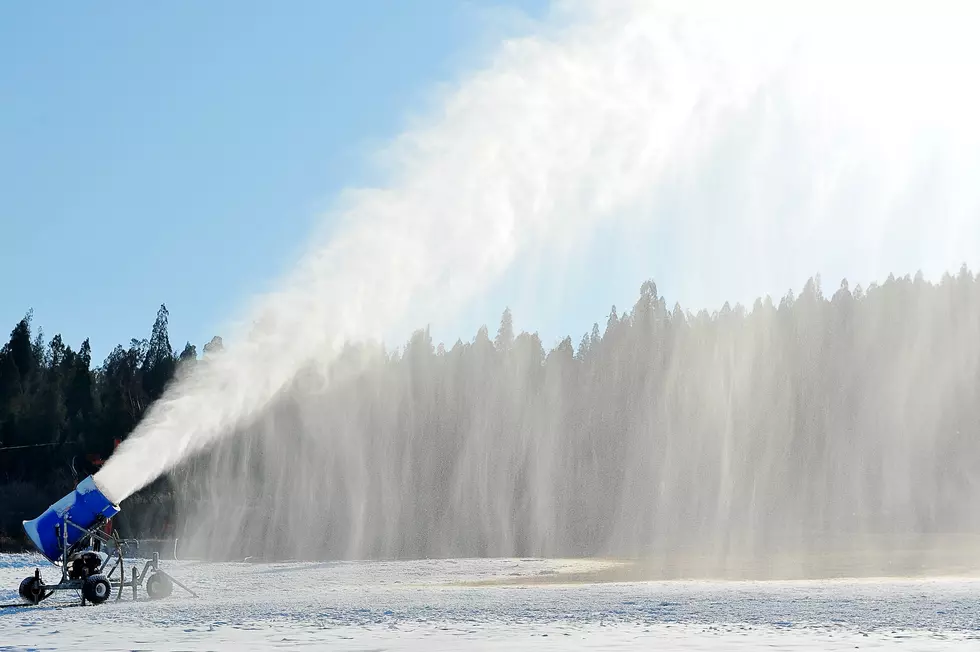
[0,555,980,652]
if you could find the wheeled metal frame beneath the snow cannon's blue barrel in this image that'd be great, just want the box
[19,514,198,605]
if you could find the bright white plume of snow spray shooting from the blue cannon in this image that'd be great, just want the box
[97,1,980,572]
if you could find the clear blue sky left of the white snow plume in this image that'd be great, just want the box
[0,0,588,362]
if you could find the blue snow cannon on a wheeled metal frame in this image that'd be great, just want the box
[14,476,197,606]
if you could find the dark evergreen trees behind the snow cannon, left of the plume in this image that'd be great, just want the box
[0,305,221,547]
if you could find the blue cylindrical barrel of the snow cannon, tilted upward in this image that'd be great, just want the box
[24,476,119,565]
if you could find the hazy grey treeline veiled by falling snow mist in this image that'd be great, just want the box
[176,268,980,558]
